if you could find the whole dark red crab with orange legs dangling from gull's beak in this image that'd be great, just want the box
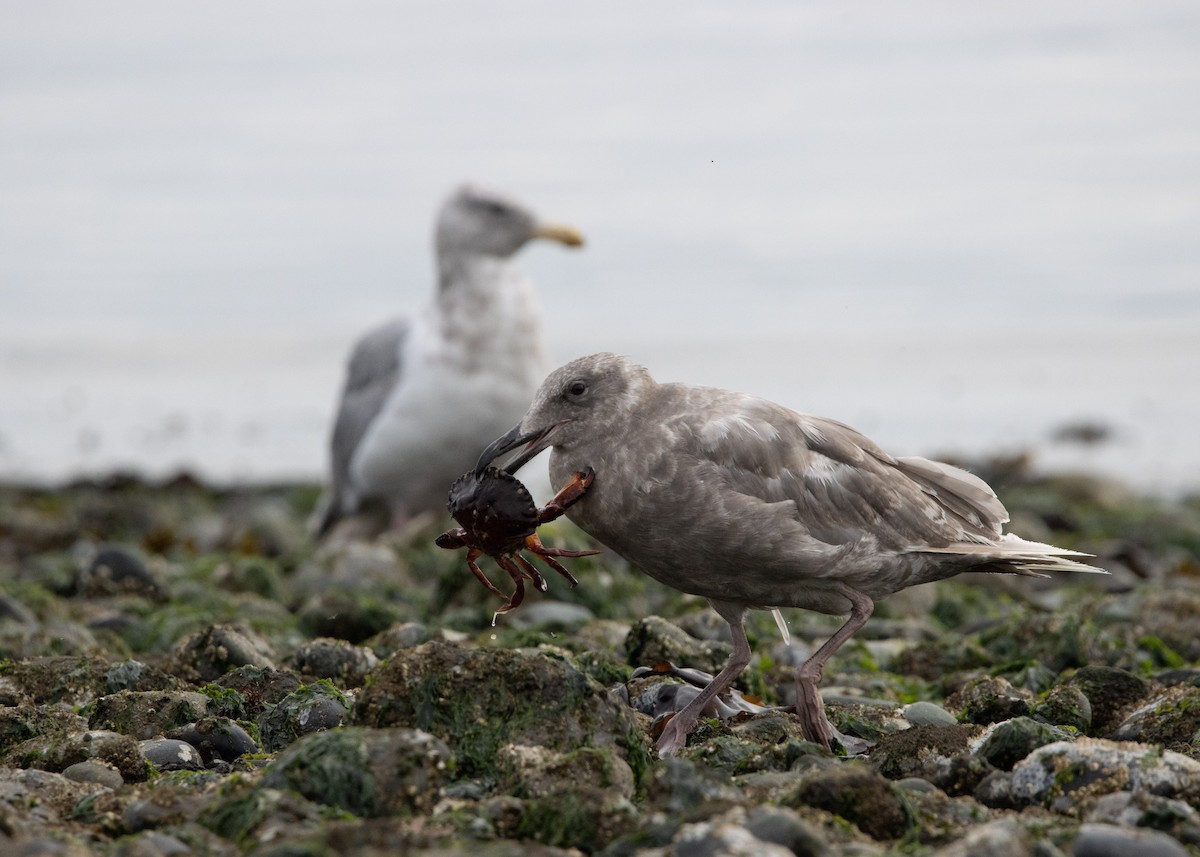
[434,467,600,615]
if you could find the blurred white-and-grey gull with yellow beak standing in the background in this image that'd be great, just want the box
[311,185,583,535]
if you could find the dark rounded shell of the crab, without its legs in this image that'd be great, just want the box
[446,467,539,556]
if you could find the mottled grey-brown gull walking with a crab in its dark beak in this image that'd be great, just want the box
[485,354,1099,753]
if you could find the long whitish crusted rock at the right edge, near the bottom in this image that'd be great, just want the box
[1012,738,1200,811]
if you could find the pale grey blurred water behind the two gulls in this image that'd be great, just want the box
[0,0,1200,493]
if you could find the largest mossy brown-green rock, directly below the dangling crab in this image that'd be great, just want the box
[354,641,649,777]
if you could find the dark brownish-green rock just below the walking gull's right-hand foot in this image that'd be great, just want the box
[782,762,911,839]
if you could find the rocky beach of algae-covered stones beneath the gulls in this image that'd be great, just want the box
[0,460,1200,857]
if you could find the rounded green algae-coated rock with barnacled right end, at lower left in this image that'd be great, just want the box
[262,726,451,816]
